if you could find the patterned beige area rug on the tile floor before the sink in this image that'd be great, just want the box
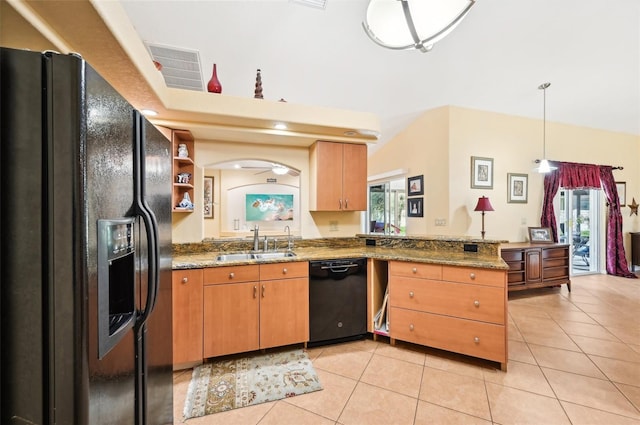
[183,349,322,419]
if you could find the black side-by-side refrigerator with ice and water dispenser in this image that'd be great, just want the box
[0,48,173,425]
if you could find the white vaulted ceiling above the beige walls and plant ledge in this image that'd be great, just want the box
[2,0,640,151]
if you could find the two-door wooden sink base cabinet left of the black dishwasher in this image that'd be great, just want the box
[203,262,309,358]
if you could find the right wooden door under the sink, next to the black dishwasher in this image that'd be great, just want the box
[260,278,309,348]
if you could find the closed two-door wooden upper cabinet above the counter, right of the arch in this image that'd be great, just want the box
[309,142,367,211]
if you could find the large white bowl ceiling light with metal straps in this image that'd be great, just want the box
[362,0,475,52]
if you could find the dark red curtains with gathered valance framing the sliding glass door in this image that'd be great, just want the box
[540,162,636,278]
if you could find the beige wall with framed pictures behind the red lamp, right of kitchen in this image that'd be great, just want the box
[369,106,640,258]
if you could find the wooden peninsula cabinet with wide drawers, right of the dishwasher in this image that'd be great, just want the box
[389,261,508,370]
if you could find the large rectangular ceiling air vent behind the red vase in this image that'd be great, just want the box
[145,43,204,91]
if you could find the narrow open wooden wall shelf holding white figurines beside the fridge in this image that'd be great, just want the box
[171,130,195,212]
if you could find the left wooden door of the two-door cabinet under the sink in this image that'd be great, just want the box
[204,282,259,357]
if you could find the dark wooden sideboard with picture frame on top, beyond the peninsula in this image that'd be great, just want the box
[500,242,571,292]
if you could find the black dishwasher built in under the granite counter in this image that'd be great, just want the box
[308,258,367,346]
